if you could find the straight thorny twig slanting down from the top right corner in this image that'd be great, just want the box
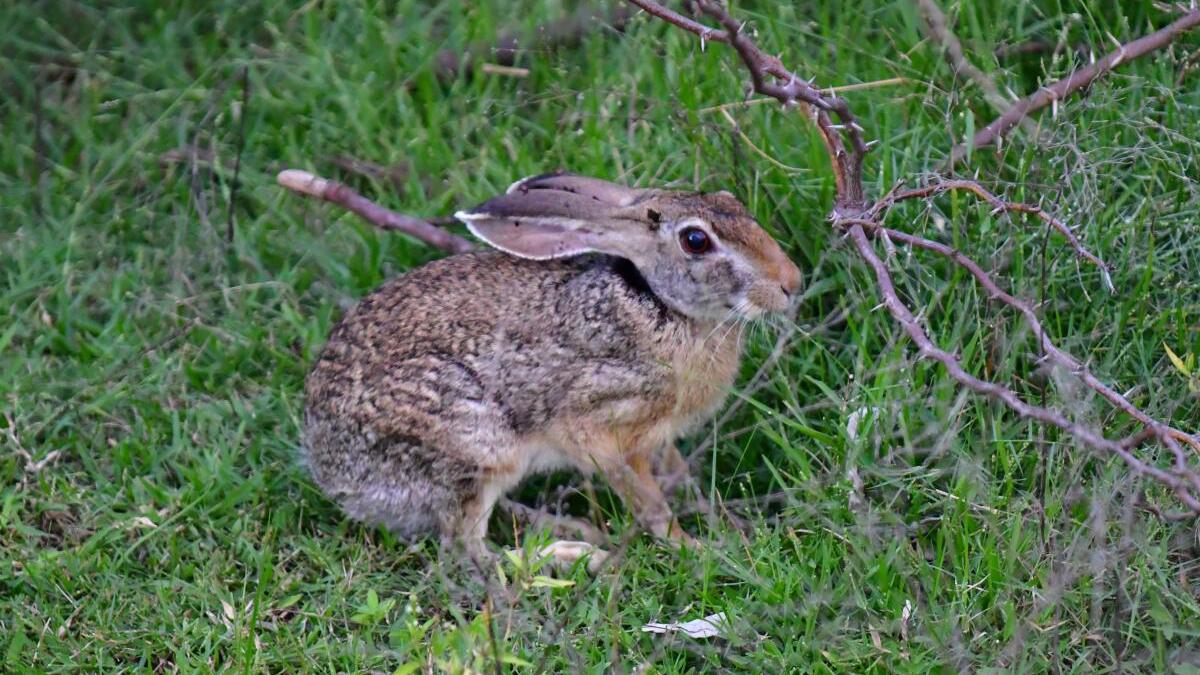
[946,10,1200,168]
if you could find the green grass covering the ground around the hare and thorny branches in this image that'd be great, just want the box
[0,0,1200,673]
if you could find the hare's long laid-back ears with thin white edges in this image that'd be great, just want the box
[455,174,655,261]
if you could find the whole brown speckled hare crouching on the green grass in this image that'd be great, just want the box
[302,173,800,561]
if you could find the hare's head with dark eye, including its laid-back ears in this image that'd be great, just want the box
[455,173,800,319]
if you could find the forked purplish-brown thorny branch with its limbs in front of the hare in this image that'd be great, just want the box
[628,0,1200,514]
